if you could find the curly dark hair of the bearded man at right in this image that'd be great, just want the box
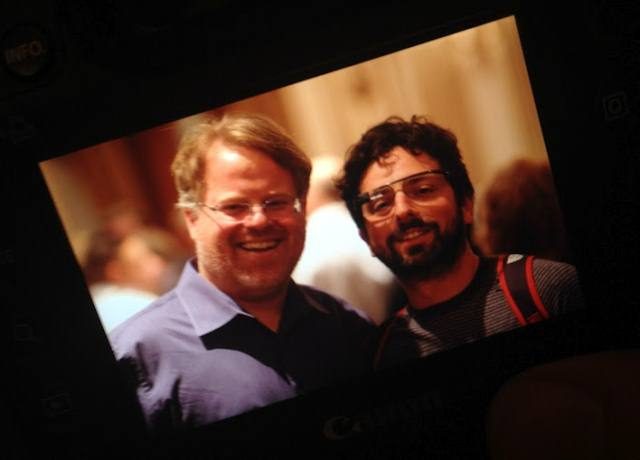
[336,115,474,229]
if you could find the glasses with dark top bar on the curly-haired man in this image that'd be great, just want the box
[355,169,449,222]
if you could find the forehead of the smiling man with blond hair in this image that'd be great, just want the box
[204,141,295,197]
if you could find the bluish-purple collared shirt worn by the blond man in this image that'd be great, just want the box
[109,262,375,432]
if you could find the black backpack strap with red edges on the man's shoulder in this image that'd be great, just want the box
[497,254,549,326]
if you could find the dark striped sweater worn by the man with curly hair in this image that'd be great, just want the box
[375,258,583,369]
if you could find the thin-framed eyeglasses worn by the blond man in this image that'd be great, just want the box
[198,195,302,222]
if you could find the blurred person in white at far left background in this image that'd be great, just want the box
[83,227,181,332]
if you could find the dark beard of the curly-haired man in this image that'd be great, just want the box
[377,209,467,281]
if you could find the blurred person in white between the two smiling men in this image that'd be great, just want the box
[292,155,399,324]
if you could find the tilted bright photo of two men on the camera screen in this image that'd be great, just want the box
[40,17,582,433]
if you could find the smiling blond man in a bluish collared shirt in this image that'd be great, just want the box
[110,115,375,434]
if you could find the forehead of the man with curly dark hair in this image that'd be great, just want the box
[359,147,440,193]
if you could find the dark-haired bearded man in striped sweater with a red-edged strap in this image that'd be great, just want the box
[337,116,582,368]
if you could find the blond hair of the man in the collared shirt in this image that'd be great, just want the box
[171,113,311,207]
